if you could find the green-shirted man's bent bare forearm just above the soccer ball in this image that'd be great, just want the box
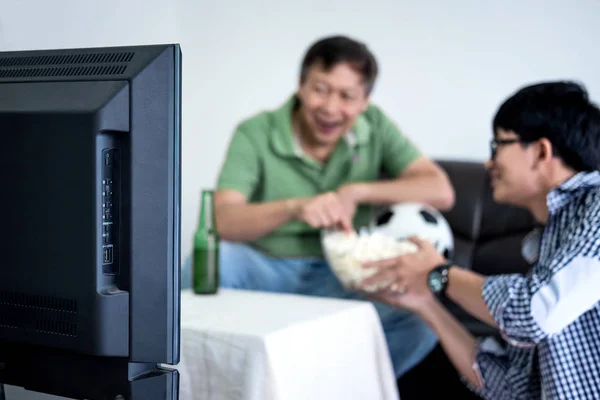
[342,156,454,211]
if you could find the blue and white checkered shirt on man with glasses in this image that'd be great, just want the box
[472,171,600,400]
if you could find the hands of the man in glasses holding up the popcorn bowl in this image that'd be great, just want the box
[361,238,445,312]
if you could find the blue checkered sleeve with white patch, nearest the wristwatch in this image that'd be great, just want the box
[483,236,600,347]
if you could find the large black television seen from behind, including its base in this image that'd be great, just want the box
[0,44,182,400]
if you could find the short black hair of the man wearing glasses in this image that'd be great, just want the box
[493,81,600,171]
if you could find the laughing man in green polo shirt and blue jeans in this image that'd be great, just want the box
[215,36,454,382]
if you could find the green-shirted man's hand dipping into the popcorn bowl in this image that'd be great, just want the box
[297,192,354,231]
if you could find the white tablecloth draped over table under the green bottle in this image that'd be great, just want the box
[176,289,398,400]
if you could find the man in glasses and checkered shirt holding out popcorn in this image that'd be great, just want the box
[363,82,600,400]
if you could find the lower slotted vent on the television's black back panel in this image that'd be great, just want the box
[0,291,77,337]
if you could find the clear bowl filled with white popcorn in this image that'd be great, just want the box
[321,230,418,292]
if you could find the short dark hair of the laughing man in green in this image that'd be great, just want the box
[300,36,378,94]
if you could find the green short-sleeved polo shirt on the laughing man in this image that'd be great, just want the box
[217,96,420,257]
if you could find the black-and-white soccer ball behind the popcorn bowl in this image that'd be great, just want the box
[371,203,454,258]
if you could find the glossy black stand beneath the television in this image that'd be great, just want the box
[0,345,179,400]
